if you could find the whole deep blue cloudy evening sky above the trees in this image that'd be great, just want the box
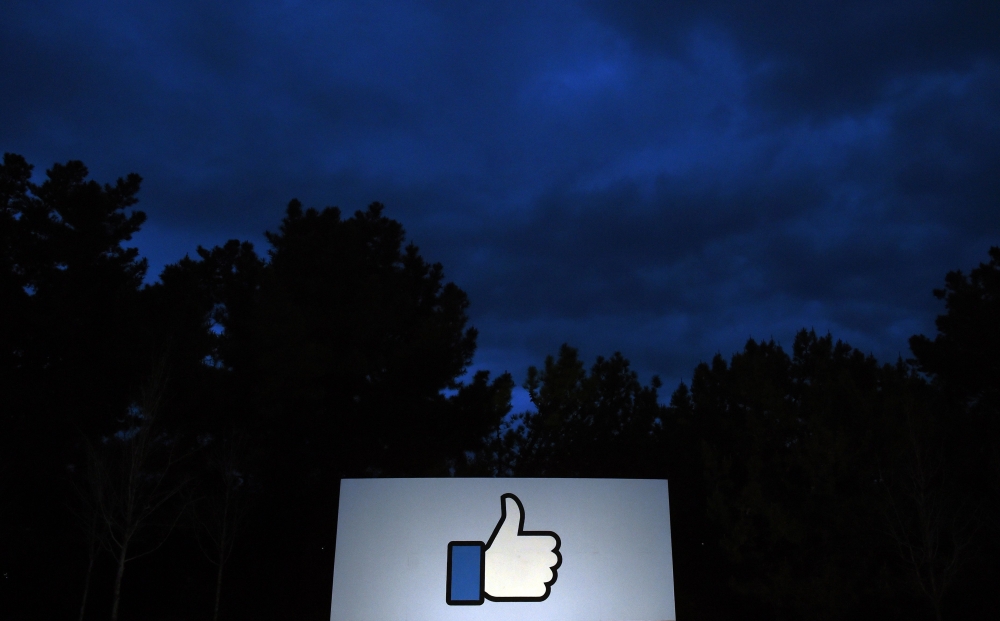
[0,0,1000,402]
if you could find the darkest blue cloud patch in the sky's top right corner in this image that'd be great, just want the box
[589,0,1000,117]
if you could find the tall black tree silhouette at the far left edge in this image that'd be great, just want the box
[0,153,146,614]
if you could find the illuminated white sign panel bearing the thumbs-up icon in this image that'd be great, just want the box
[330,479,675,621]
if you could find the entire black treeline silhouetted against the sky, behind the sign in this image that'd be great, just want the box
[0,154,1000,621]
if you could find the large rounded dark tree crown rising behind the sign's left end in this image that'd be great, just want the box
[261,201,476,476]
